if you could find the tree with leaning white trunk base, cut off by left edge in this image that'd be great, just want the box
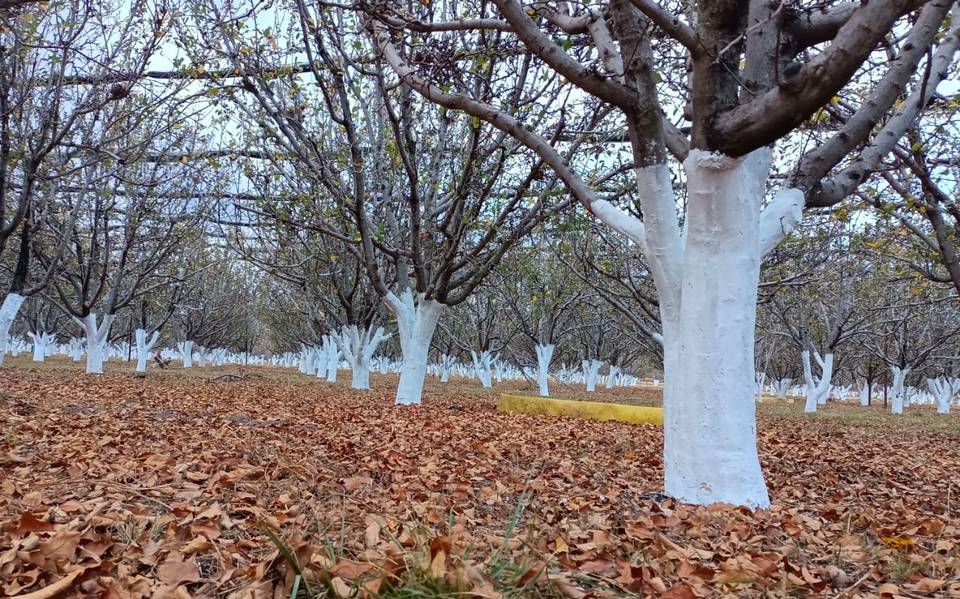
[0,0,166,362]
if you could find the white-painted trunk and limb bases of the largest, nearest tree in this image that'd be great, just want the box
[590,148,804,507]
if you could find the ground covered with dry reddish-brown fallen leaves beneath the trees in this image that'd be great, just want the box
[0,360,960,599]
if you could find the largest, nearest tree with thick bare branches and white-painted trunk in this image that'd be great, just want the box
[357,0,960,506]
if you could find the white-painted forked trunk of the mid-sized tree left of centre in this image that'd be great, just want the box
[384,289,443,405]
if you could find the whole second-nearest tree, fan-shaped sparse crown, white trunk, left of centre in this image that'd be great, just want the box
[188,0,590,404]
